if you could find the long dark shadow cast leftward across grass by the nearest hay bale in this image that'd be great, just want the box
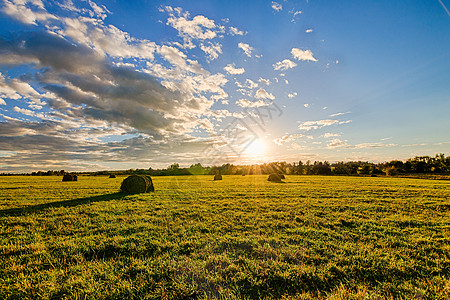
[0,192,127,216]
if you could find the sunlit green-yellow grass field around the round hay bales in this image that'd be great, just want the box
[0,175,450,299]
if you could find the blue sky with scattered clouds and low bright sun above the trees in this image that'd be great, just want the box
[0,0,450,172]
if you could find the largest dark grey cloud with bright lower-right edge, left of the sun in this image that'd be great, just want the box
[0,32,212,135]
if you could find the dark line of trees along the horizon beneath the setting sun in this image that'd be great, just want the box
[14,153,450,176]
